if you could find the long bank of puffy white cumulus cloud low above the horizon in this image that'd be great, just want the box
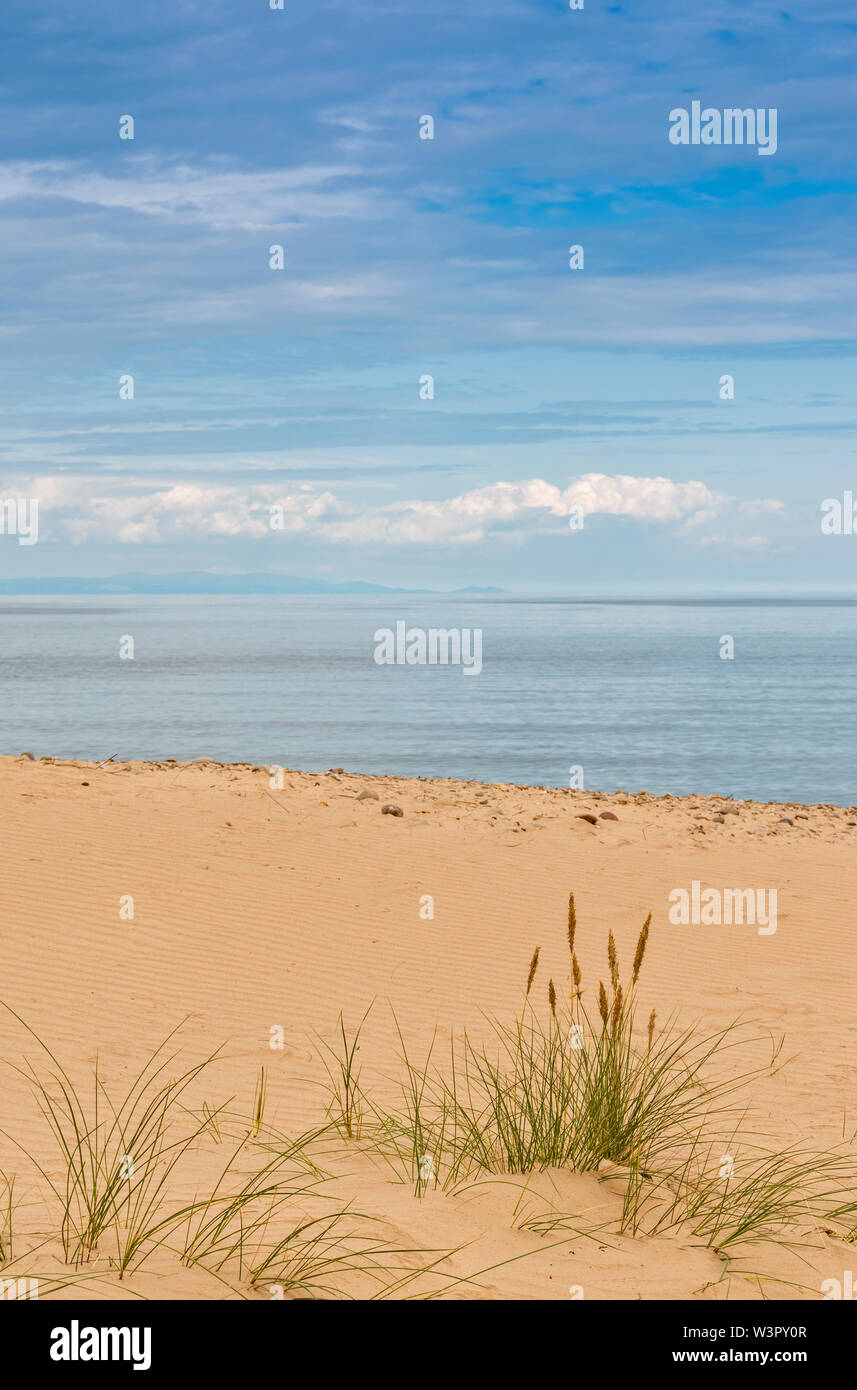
[6,473,781,548]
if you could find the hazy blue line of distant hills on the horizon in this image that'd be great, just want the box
[0,570,503,595]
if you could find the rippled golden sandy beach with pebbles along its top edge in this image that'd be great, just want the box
[0,756,857,1300]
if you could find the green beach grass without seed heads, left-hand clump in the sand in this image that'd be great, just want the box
[0,1006,461,1298]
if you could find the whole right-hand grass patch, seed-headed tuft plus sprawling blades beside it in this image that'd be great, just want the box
[320,894,857,1250]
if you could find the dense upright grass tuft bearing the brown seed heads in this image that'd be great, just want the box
[342,897,766,1186]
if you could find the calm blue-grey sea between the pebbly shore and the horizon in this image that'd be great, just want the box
[0,595,857,805]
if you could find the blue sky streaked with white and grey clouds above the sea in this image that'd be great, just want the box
[0,0,857,592]
